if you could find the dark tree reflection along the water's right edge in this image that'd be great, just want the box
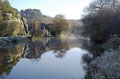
[82,42,104,79]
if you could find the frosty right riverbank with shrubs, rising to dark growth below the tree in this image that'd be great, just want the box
[88,37,120,79]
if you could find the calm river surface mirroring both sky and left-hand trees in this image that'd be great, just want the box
[0,38,87,79]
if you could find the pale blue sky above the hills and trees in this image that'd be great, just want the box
[9,0,91,19]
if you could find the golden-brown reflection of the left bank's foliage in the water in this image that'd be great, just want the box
[0,45,24,79]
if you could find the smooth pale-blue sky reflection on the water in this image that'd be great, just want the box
[7,48,86,79]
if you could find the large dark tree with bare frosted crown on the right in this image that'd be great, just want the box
[82,0,120,42]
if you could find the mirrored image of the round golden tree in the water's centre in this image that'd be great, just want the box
[48,38,70,58]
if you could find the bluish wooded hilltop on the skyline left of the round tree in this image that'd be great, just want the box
[20,9,53,24]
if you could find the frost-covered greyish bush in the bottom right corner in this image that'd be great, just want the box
[88,51,120,79]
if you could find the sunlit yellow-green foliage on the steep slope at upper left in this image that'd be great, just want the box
[0,0,24,36]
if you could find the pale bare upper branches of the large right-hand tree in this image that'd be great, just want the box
[85,0,120,14]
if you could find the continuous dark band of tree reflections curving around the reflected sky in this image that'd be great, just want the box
[0,38,104,79]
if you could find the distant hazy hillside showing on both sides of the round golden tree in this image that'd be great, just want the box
[20,9,82,35]
